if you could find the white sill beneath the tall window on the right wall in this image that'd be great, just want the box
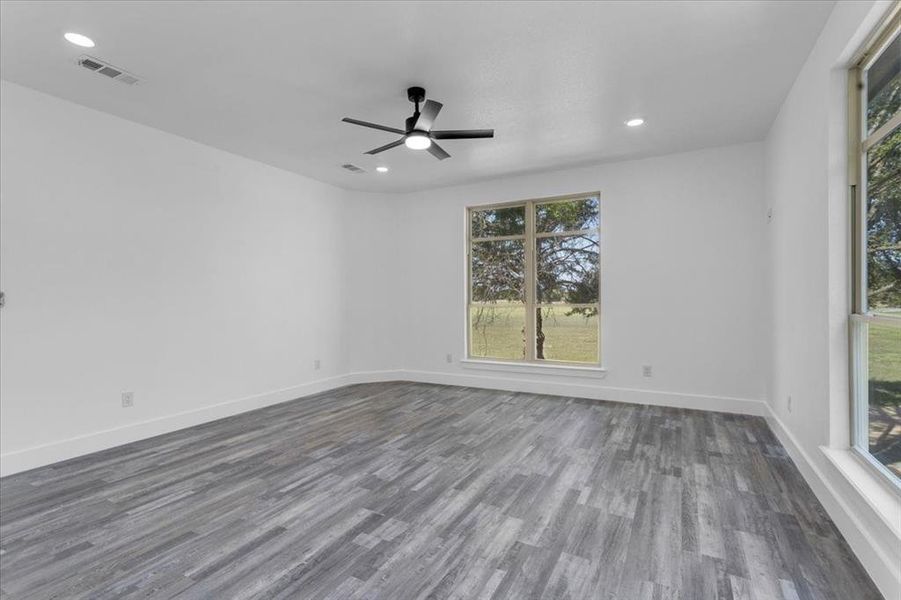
[820,446,901,538]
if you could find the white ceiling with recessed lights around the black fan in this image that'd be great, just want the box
[0,1,833,191]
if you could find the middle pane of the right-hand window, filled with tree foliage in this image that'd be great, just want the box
[867,127,901,314]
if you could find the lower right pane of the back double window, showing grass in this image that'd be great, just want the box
[535,306,598,364]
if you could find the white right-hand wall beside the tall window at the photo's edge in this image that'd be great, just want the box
[765,2,901,598]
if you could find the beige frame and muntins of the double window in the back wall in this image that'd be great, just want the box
[461,191,606,366]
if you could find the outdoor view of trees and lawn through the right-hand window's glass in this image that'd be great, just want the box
[866,37,901,477]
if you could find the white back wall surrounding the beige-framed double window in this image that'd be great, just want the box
[386,144,766,412]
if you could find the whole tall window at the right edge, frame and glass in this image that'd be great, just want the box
[849,11,901,482]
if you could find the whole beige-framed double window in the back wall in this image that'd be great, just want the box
[467,193,600,365]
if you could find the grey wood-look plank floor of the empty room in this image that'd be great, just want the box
[0,382,880,600]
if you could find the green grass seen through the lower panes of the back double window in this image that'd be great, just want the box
[469,303,598,363]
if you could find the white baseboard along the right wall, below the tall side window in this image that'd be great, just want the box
[766,404,901,600]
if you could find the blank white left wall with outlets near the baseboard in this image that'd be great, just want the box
[0,82,346,472]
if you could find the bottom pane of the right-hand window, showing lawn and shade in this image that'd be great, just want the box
[868,323,901,477]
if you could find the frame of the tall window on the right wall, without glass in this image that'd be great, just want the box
[848,7,901,489]
